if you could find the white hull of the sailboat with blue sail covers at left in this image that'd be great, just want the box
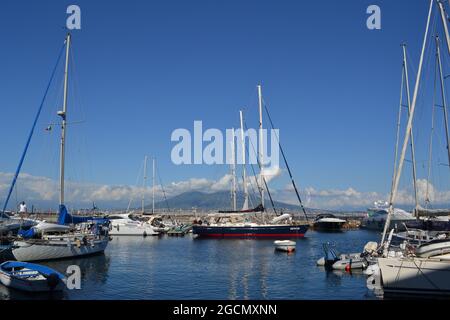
[12,239,108,261]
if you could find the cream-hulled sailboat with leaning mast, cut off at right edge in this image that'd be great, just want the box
[368,0,450,296]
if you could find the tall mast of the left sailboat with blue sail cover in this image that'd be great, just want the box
[58,33,71,205]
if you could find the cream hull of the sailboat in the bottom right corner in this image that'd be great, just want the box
[378,258,450,296]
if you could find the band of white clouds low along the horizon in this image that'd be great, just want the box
[0,171,450,209]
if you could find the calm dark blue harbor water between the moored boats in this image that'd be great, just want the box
[0,230,380,300]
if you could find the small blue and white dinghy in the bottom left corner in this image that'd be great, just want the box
[0,261,65,292]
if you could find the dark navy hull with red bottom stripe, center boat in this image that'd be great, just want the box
[192,224,309,238]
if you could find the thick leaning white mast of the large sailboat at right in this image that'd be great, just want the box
[381,0,434,248]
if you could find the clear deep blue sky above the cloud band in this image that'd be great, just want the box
[0,0,450,210]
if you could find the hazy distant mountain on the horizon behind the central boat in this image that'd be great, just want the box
[153,191,342,213]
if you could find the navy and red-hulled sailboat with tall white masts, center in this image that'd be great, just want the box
[192,85,309,238]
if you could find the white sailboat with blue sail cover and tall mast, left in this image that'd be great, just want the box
[12,33,109,261]
